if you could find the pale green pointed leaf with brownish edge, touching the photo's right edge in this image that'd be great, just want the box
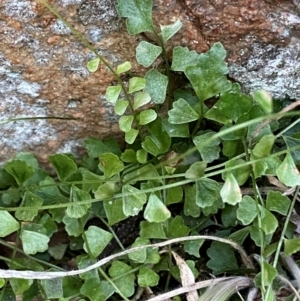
[276,153,300,187]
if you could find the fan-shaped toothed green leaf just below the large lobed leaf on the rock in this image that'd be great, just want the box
[168,98,200,124]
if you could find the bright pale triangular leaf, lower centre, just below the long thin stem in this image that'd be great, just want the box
[144,193,171,223]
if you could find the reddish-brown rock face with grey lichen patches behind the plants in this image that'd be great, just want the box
[0,0,300,163]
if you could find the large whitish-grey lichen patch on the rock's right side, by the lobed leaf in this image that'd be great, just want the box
[229,38,300,99]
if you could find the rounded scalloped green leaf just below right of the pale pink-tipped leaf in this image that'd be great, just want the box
[236,195,257,225]
